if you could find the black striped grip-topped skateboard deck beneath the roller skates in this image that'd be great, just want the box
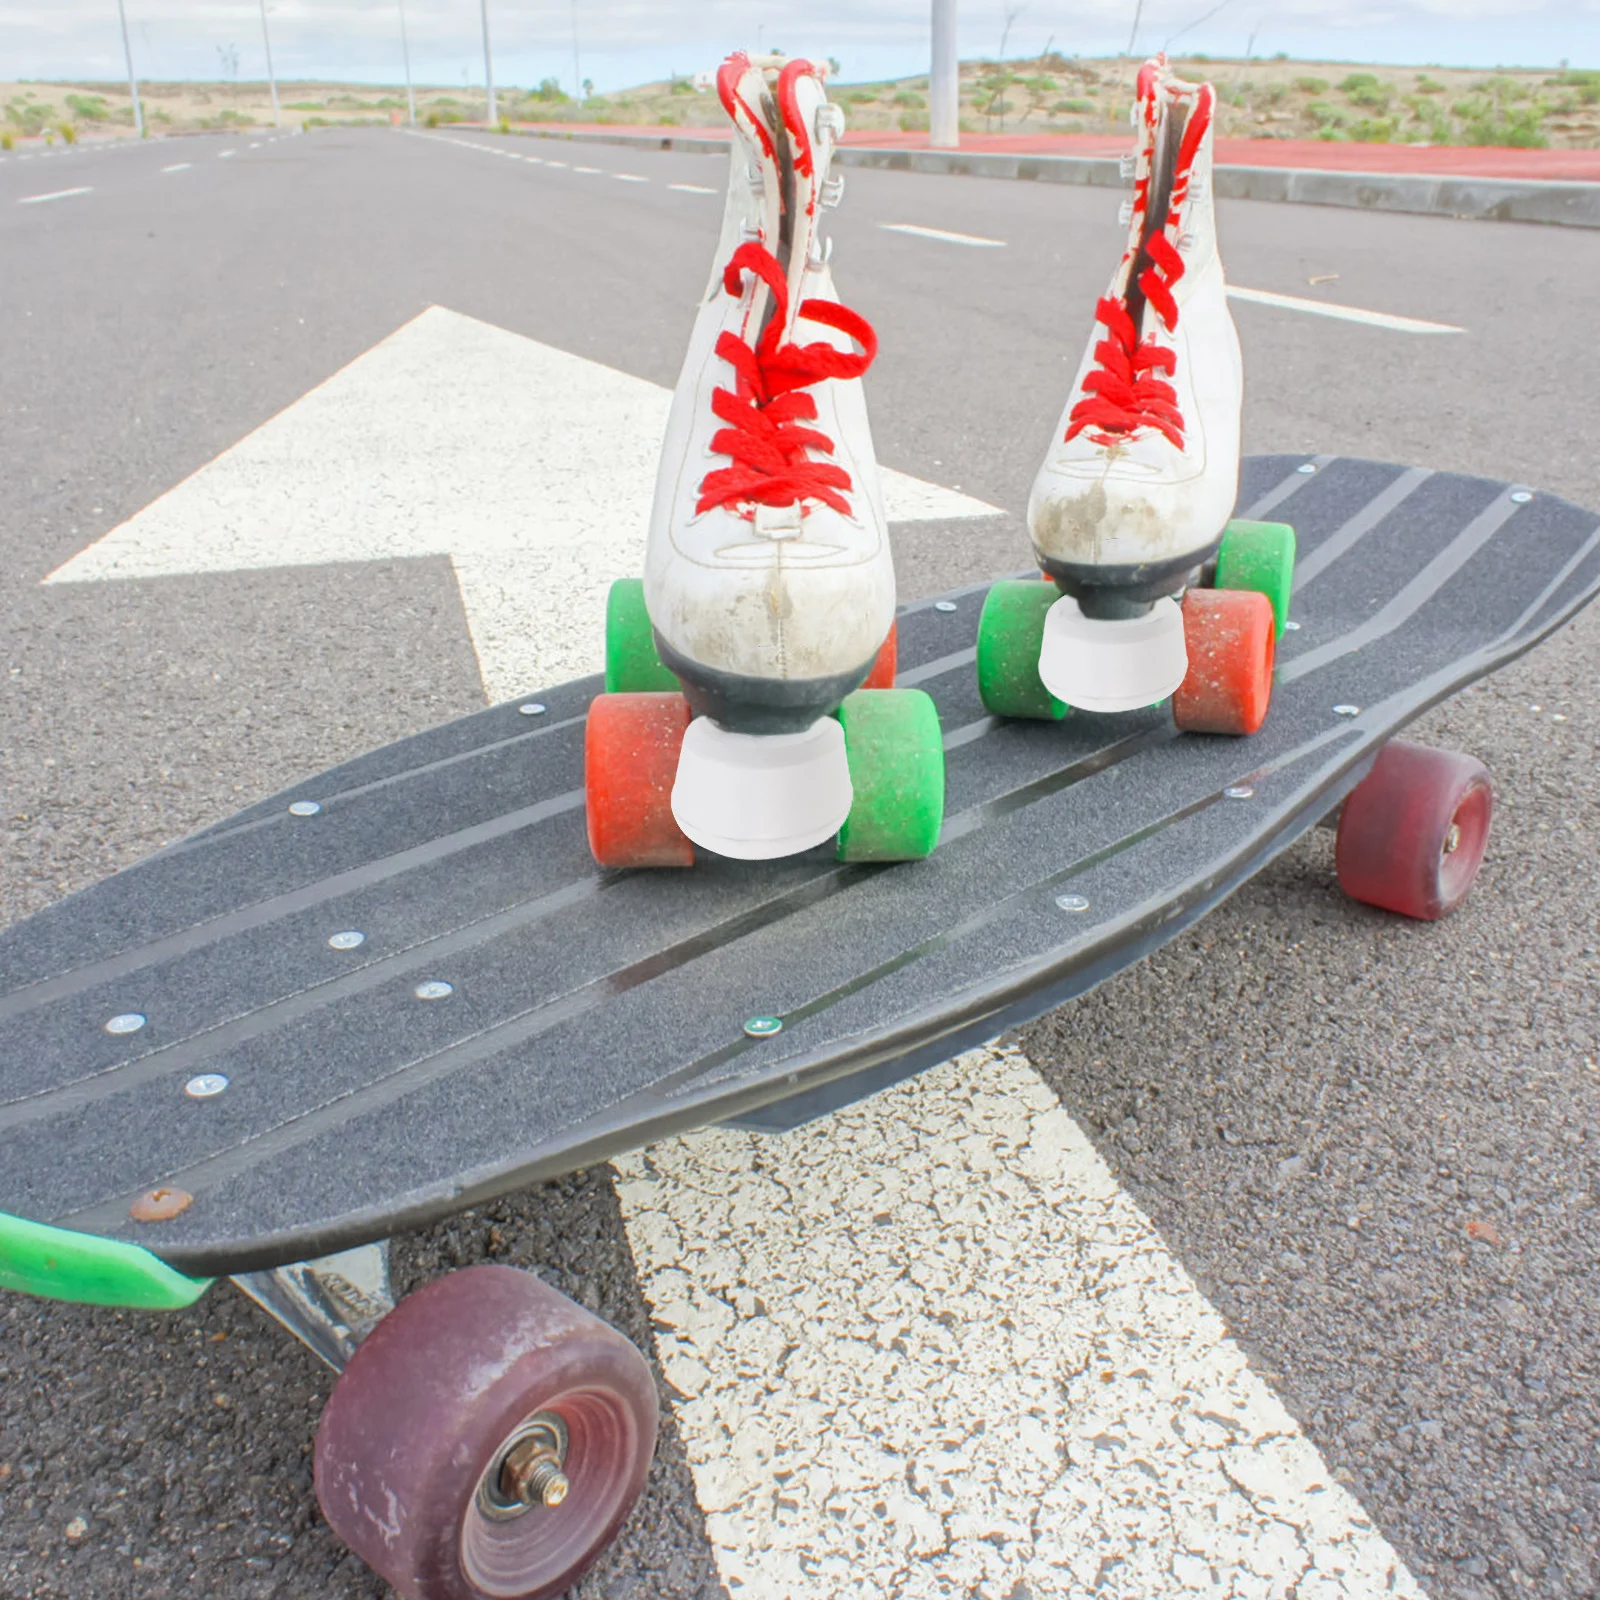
[0,456,1600,1275]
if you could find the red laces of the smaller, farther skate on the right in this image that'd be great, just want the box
[1067,82,1214,450]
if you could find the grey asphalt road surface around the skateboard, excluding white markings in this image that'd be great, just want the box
[0,131,1600,1600]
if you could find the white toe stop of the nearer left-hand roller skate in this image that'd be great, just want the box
[672,717,854,861]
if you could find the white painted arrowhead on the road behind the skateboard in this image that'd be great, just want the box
[45,306,998,701]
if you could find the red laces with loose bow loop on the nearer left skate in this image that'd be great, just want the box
[694,240,878,517]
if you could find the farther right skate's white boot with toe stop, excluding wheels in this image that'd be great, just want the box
[1027,58,1243,710]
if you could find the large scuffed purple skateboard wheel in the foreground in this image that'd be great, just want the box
[314,1266,658,1600]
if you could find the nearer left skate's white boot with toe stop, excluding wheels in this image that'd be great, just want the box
[645,54,894,859]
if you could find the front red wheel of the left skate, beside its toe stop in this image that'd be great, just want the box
[584,694,694,867]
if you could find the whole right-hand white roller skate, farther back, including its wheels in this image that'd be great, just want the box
[978,58,1294,733]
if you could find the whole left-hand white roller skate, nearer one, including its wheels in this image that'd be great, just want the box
[584,53,944,867]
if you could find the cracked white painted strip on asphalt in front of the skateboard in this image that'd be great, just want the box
[618,1050,1421,1600]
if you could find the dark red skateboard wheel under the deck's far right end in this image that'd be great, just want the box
[1334,739,1494,922]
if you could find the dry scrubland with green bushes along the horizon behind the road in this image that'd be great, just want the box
[0,60,1600,149]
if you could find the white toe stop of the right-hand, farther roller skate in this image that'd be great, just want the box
[1038,595,1189,712]
